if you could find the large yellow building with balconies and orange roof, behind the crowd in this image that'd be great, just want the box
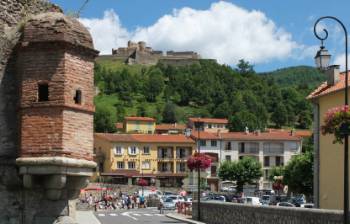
[94,133,195,187]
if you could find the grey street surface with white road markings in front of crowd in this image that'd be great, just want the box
[95,208,183,224]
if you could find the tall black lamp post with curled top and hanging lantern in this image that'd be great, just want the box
[314,16,350,224]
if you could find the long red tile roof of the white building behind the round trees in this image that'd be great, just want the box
[221,131,301,141]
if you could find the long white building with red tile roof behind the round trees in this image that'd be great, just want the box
[220,130,302,189]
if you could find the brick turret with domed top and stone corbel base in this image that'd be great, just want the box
[17,13,98,200]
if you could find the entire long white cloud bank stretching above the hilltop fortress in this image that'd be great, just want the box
[81,1,303,64]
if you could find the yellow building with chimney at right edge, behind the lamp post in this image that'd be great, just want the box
[308,68,345,209]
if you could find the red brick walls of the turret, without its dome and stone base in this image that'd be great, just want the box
[18,46,94,160]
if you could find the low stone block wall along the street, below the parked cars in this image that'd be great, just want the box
[192,202,343,224]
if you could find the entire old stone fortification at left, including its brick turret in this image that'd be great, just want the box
[0,0,97,224]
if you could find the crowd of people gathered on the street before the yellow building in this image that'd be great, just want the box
[85,191,147,210]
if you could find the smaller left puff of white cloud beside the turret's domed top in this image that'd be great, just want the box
[79,10,131,54]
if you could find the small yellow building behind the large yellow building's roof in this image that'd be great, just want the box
[123,117,156,134]
